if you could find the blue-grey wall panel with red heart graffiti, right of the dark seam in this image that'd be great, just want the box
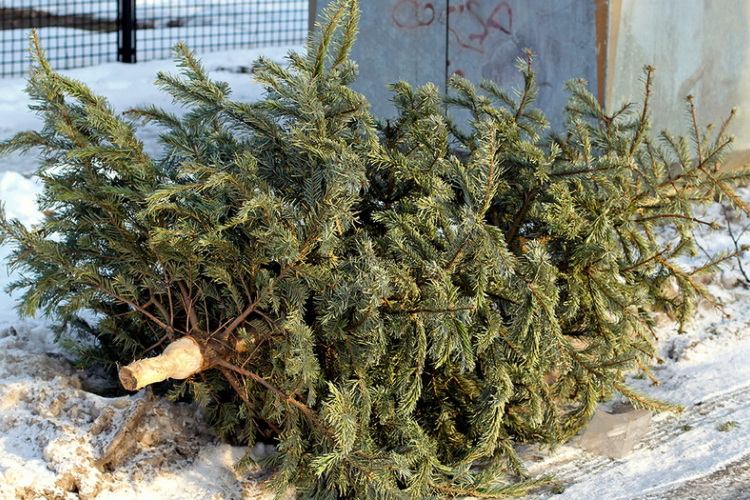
[448,0,597,129]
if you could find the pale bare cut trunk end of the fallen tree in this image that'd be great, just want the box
[120,337,203,391]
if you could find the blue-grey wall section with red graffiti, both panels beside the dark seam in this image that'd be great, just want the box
[317,0,598,126]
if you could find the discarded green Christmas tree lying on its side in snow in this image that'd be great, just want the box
[0,0,747,499]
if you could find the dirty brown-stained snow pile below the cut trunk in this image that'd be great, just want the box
[0,327,284,500]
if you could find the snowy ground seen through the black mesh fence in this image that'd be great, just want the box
[0,0,308,74]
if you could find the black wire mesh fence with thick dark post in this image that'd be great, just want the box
[0,0,308,77]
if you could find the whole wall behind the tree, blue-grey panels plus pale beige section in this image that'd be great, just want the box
[311,0,750,156]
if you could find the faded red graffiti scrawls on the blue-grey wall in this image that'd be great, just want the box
[393,0,513,54]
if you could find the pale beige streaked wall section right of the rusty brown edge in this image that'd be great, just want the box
[609,0,750,151]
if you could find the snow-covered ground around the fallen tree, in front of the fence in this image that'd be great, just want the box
[0,49,750,500]
